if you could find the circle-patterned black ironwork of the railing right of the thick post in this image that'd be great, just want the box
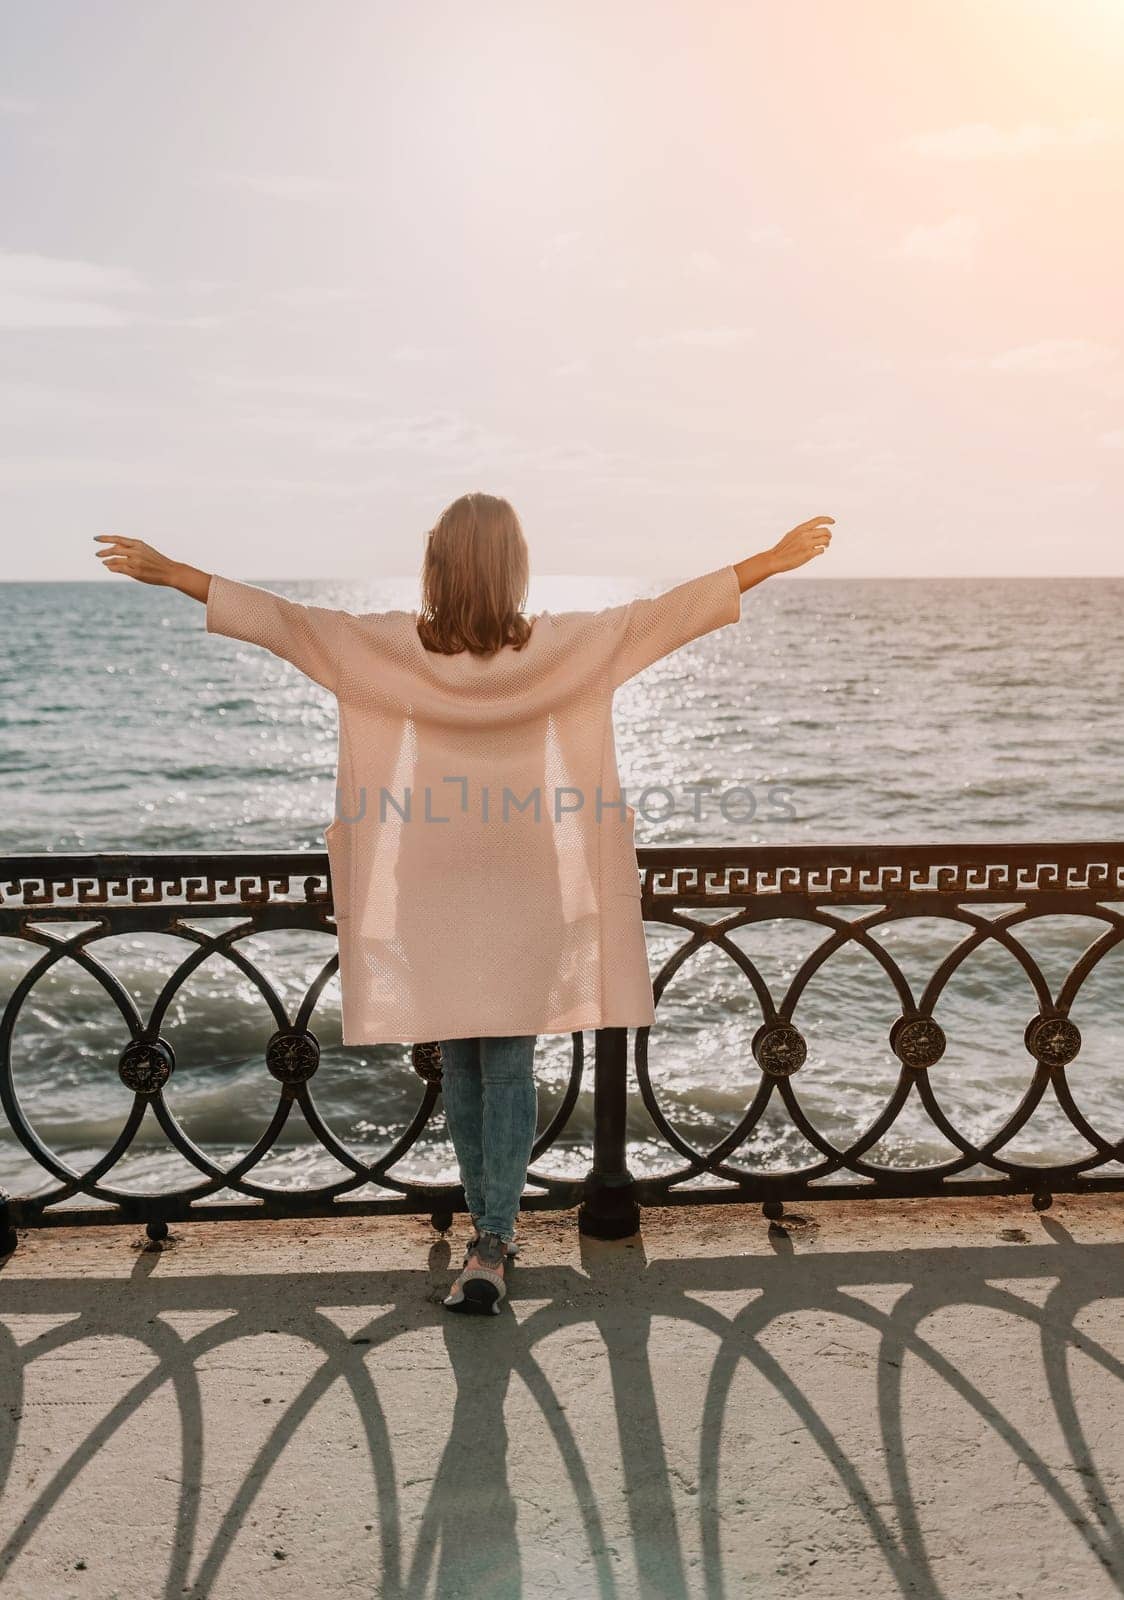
[636,846,1124,1205]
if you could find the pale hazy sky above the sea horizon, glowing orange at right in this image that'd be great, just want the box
[0,0,1124,582]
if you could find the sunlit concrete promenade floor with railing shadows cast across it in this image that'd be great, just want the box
[0,1197,1124,1600]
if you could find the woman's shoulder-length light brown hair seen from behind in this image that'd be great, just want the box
[418,491,532,656]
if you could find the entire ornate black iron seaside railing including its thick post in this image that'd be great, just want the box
[0,843,1124,1248]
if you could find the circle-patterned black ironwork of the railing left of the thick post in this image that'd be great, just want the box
[0,854,584,1237]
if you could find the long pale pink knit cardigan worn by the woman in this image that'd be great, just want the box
[207,566,741,1045]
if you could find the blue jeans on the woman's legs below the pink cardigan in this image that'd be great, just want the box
[440,1034,538,1240]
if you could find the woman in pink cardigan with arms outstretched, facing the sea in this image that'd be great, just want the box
[96,493,834,1312]
